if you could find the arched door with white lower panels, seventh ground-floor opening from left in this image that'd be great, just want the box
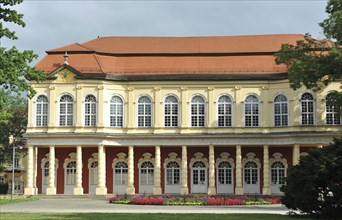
[191,161,208,193]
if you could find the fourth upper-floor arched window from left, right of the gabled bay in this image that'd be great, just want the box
[110,96,123,127]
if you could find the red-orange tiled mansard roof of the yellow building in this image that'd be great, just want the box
[37,34,304,75]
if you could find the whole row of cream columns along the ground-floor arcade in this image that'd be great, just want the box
[24,144,300,195]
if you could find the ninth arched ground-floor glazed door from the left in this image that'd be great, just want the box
[243,161,260,194]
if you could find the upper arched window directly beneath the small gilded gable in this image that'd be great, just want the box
[59,95,74,126]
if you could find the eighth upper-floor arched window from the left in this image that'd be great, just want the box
[217,95,232,127]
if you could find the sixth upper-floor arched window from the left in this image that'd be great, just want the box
[164,96,178,127]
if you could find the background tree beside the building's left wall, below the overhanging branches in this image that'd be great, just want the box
[0,89,27,162]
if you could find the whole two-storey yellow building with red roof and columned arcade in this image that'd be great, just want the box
[25,35,342,195]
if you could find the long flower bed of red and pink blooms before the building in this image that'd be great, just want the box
[109,195,280,206]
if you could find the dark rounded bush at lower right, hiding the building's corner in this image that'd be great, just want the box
[281,139,342,219]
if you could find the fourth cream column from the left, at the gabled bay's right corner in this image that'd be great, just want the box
[95,145,107,195]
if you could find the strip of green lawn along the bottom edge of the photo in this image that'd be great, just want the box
[0,213,309,220]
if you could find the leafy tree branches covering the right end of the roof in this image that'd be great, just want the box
[275,0,342,112]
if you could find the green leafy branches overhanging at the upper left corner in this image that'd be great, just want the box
[0,0,45,123]
